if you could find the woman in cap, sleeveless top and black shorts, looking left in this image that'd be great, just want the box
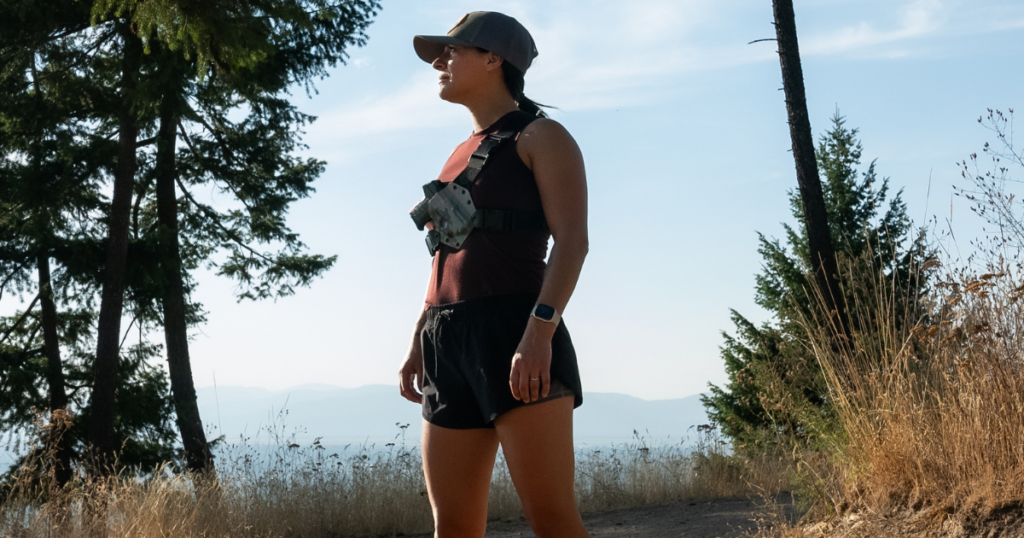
[399,11,588,538]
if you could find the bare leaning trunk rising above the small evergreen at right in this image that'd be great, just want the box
[773,0,847,333]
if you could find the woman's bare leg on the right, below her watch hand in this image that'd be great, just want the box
[495,397,589,538]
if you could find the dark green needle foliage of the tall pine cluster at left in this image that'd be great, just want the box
[0,0,380,469]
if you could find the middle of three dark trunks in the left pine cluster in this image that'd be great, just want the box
[89,25,142,465]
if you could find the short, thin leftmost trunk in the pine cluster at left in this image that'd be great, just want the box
[39,254,72,488]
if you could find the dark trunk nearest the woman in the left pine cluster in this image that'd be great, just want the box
[157,81,213,472]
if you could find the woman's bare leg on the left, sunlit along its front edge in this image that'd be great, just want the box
[423,421,498,538]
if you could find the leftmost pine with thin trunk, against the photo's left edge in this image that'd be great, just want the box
[0,2,102,486]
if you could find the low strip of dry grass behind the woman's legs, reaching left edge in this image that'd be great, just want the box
[0,429,786,538]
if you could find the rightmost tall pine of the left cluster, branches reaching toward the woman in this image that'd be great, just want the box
[133,2,376,469]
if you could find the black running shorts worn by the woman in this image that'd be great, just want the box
[420,295,583,429]
